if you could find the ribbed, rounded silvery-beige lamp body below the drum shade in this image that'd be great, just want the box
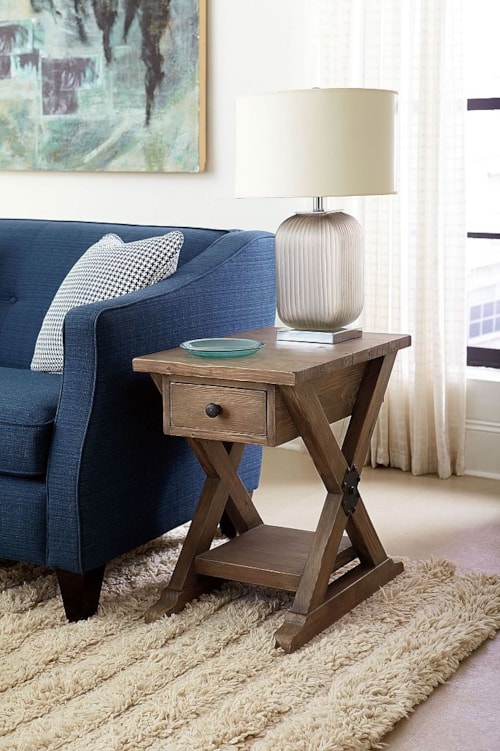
[276,211,364,331]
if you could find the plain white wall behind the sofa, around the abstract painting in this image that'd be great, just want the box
[0,0,309,231]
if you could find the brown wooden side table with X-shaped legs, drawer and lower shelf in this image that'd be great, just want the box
[133,328,410,652]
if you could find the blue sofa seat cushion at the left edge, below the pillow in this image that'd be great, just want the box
[0,367,62,477]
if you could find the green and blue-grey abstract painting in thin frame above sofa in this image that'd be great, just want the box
[0,0,206,172]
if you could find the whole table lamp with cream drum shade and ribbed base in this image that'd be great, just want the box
[235,88,397,342]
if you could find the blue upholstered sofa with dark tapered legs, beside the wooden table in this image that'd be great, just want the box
[0,219,275,620]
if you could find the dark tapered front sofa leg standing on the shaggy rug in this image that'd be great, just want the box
[56,566,105,622]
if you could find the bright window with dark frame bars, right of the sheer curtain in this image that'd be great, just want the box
[465,0,500,368]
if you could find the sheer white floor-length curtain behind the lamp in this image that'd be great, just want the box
[306,0,466,477]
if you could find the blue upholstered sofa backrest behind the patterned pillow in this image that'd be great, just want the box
[0,219,227,368]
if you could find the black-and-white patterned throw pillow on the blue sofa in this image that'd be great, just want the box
[31,231,184,373]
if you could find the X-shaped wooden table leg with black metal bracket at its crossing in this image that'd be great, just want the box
[275,355,403,652]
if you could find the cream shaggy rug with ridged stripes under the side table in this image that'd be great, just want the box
[0,529,500,751]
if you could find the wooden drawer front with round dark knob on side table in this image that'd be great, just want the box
[169,381,267,438]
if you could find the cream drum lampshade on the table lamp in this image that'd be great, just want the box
[235,88,397,197]
